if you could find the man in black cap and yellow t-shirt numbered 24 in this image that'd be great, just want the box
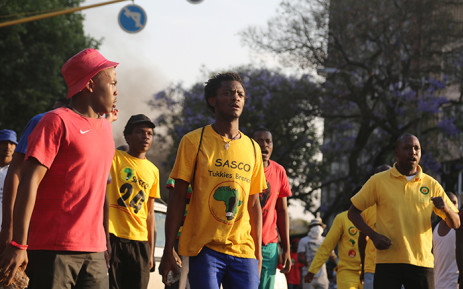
[106,114,161,289]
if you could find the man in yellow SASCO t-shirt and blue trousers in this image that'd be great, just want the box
[160,73,266,289]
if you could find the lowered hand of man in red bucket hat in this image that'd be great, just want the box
[0,245,28,286]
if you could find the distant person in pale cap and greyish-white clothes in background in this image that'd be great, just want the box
[297,218,336,289]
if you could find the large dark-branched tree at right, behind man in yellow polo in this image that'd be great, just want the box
[242,0,463,216]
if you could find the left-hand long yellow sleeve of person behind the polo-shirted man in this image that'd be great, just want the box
[309,215,342,274]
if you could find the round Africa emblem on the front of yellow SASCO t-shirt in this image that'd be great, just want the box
[209,181,244,225]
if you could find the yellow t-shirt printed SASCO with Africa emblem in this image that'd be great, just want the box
[170,125,267,258]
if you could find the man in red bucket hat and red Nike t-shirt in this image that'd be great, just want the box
[0,49,118,289]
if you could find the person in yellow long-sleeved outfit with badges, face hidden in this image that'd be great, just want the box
[304,211,362,289]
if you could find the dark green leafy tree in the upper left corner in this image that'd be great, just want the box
[0,0,99,134]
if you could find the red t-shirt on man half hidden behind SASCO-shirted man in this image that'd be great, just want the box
[259,160,291,245]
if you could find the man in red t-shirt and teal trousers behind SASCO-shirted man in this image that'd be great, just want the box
[253,128,291,289]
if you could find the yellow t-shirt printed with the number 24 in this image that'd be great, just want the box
[106,150,161,241]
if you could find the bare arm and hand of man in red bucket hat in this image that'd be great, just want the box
[0,158,47,285]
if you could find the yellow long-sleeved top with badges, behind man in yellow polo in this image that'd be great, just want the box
[309,211,361,274]
